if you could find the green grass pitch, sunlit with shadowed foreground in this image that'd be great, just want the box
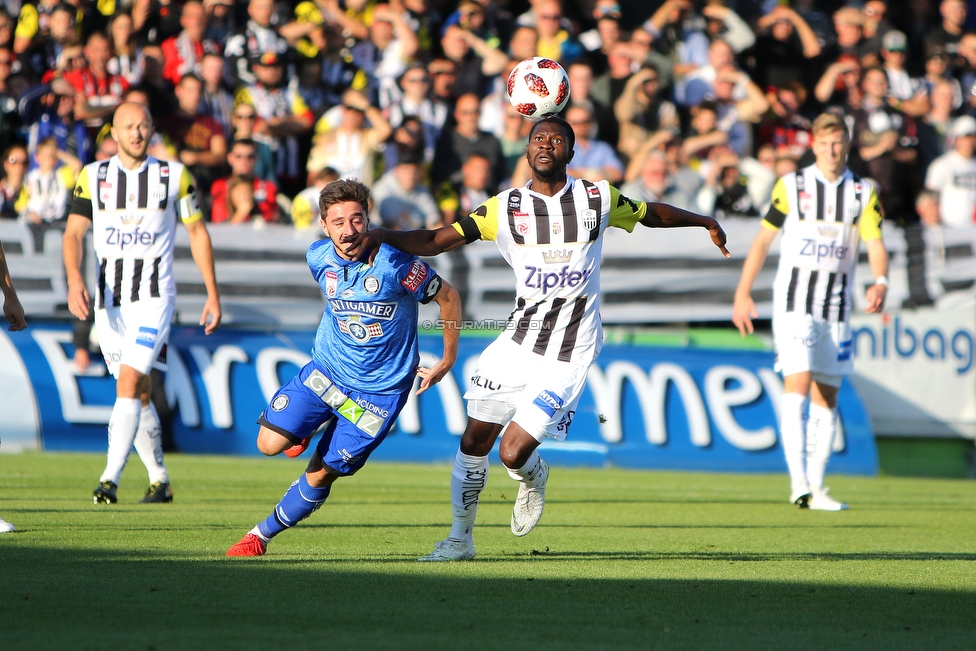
[0,454,976,651]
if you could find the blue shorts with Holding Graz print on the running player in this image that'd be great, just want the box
[258,362,410,475]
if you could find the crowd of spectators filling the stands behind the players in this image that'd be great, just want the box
[0,0,976,237]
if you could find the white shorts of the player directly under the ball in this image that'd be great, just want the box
[464,335,589,442]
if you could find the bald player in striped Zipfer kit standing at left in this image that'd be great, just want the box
[62,102,220,504]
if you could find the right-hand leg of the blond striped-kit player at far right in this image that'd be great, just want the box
[807,374,848,511]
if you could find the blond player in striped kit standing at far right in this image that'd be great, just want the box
[732,113,888,511]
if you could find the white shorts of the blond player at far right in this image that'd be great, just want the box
[773,313,854,386]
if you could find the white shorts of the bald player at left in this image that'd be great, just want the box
[95,299,174,379]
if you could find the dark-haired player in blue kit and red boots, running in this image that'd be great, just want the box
[227,181,461,556]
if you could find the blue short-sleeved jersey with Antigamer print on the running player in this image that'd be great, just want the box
[305,240,441,393]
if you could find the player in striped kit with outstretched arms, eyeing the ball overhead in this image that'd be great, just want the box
[350,117,729,561]
